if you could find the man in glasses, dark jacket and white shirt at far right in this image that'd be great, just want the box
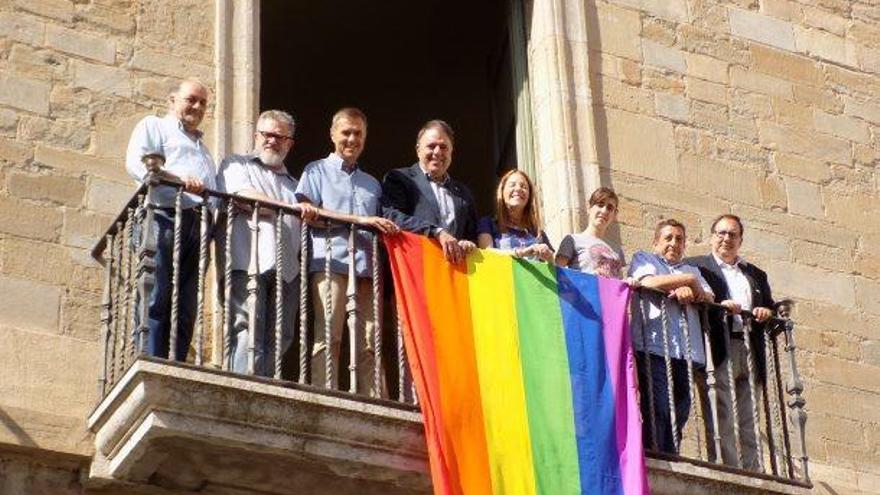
[685,214,774,471]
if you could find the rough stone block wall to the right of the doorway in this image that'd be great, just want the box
[587,0,880,493]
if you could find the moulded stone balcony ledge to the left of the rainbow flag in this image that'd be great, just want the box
[88,359,431,495]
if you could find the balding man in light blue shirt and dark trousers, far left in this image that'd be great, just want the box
[125,79,216,361]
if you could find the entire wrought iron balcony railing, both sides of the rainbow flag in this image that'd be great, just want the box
[92,175,810,486]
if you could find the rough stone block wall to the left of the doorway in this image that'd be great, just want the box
[0,0,214,484]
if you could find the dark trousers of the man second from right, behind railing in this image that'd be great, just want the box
[636,352,698,454]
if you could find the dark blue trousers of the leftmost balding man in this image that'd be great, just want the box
[135,208,200,361]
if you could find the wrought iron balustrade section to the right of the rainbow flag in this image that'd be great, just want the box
[630,288,811,486]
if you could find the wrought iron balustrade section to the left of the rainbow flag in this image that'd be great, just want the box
[92,176,415,403]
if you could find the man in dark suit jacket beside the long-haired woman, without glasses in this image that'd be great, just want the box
[382,120,477,263]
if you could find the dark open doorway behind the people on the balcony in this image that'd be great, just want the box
[260,0,516,215]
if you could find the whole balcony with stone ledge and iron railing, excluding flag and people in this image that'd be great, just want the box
[88,179,811,495]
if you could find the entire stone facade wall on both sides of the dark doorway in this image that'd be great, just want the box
[0,0,880,493]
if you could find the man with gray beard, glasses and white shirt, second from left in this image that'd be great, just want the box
[218,110,316,376]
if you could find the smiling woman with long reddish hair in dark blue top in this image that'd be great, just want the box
[477,170,553,261]
